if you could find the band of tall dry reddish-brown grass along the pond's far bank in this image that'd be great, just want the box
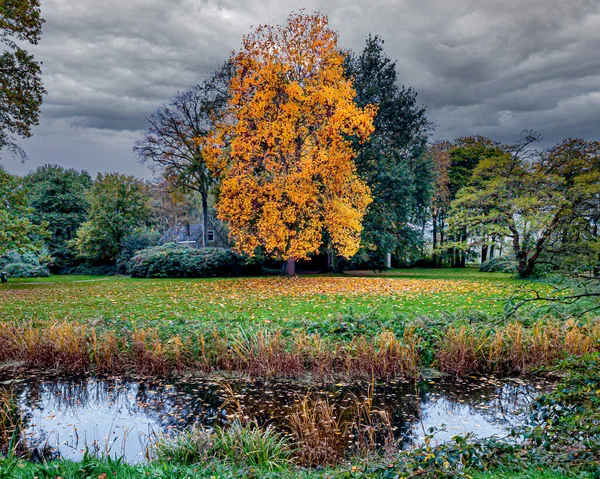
[0,319,600,380]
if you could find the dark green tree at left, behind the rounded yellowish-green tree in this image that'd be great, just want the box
[23,165,92,268]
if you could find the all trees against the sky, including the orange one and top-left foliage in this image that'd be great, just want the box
[0,7,600,277]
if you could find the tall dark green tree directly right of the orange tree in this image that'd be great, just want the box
[345,35,433,270]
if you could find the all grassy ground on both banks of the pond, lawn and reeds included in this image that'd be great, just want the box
[0,269,600,479]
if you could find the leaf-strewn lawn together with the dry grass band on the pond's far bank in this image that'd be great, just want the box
[0,269,600,379]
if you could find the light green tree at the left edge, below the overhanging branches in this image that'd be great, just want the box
[0,167,45,255]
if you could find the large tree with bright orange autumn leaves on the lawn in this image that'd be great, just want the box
[205,13,375,274]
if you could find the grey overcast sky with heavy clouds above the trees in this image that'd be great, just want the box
[2,0,600,178]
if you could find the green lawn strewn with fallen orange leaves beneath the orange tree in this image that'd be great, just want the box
[0,269,523,338]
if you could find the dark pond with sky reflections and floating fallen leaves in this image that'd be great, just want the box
[0,371,553,463]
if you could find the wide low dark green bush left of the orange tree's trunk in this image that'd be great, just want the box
[127,243,248,278]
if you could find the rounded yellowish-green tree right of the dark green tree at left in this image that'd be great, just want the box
[74,173,150,263]
